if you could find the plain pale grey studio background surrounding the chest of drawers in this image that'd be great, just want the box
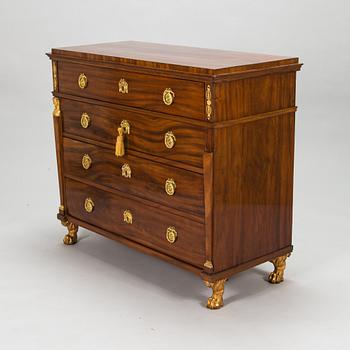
[0,0,350,350]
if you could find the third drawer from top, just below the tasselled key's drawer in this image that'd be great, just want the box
[63,138,204,215]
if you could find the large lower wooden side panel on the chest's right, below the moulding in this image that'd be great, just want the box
[213,113,294,272]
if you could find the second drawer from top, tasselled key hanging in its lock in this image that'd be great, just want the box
[61,99,206,167]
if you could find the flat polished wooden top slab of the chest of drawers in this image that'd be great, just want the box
[52,41,298,74]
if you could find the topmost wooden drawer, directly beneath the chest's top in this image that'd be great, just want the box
[58,62,205,120]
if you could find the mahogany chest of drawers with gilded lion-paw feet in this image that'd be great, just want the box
[48,42,301,309]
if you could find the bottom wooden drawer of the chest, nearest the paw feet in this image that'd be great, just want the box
[65,179,205,266]
